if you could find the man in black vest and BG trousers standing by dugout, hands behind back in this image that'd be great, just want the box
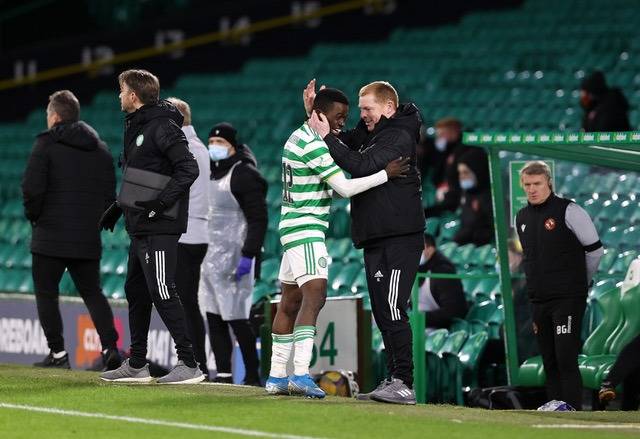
[516,162,604,410]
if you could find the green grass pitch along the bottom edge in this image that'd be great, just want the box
[0,365,640,439]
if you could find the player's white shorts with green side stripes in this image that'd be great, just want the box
[278,242,329,287]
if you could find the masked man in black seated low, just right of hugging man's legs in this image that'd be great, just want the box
[418,233,467,329]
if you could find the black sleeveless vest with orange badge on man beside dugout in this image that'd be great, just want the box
[516,194,588,302]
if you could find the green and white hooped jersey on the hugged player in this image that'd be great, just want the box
[278,122,342,250]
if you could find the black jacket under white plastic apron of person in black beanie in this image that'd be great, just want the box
[211,145,268,260]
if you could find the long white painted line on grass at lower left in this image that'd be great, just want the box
[0,402,320,439]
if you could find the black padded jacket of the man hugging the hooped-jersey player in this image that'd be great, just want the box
[324,104,424,248]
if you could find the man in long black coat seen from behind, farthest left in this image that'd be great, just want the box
[22,90,120,369]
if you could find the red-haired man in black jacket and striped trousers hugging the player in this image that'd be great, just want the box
[305,81,425,404]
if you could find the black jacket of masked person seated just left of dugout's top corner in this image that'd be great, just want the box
[453,148,494,245]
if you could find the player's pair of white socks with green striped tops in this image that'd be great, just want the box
[270,326,316,378]
